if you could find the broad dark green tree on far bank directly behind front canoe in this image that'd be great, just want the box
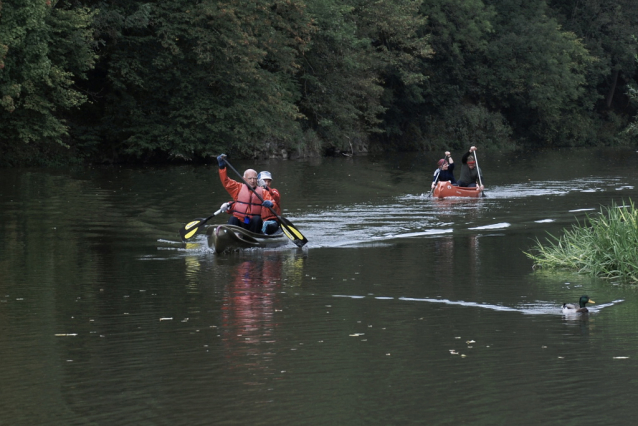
[77,0,312,159]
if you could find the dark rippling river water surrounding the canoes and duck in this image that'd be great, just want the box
[0,150,638,425]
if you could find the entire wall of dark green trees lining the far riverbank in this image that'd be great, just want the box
[0,0,638,165]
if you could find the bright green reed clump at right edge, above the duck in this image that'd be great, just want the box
[525,201,638,281]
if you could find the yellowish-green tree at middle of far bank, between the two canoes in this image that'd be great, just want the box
[300,0,432,152]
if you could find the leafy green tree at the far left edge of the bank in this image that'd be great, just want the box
[0,0,95,155]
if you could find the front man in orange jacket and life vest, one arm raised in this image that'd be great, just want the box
[217,154,277,234]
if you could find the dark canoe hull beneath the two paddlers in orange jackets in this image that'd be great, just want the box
[206,225,288,253]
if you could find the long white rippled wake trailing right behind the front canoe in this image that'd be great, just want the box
[284,178,633,248]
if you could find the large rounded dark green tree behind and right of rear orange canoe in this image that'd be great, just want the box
[413,0,593,147]
